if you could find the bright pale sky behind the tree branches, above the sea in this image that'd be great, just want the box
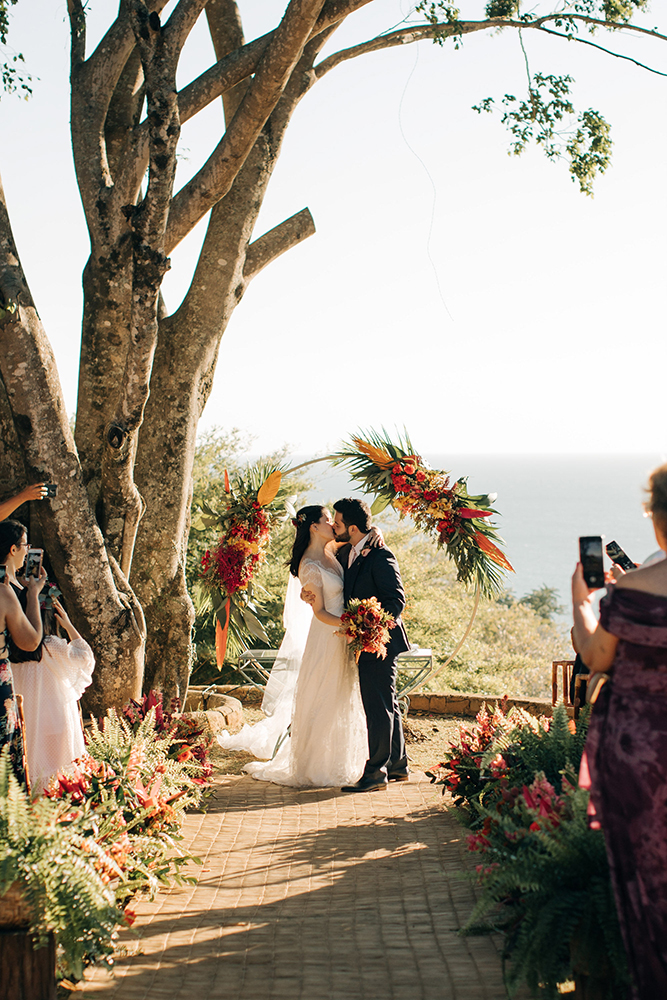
[0,0,667,453]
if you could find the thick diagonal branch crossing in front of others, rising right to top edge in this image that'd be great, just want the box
[166,0,324,253]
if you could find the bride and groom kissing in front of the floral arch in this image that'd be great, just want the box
[218,497,410,792]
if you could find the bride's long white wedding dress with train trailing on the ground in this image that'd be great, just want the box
[218,556,368,787]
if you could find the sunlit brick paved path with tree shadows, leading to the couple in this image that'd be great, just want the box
[83,775,516,1000]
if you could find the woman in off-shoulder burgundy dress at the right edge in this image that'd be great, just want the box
[572,465,667,1000]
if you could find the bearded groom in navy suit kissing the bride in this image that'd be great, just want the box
[333,498,410,792]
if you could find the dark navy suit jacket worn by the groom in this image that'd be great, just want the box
[337,545,410,661]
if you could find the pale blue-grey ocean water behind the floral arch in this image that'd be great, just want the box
[294,454,664,620]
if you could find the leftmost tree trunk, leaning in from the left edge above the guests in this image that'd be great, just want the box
[0,174,145,713]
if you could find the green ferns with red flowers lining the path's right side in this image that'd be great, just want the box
[428,704,629,1000]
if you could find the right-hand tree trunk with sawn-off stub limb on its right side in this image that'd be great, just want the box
[131,31,324,698]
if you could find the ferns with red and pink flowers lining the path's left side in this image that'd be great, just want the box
[0,692,211,981]
